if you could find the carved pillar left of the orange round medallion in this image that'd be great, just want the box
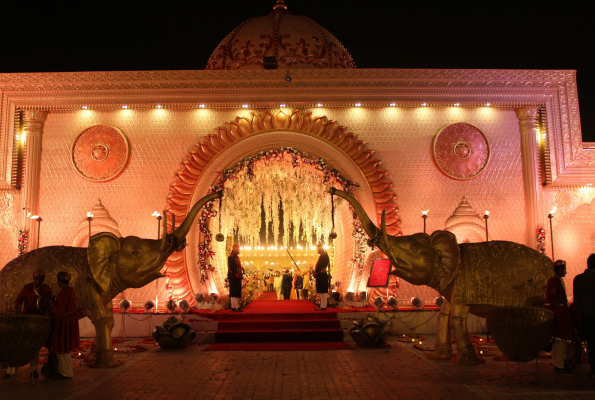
[20,111,47,249]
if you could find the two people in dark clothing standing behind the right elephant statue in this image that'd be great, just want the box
[545,254,595,376]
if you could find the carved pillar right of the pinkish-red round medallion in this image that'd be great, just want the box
[516,108,544,249]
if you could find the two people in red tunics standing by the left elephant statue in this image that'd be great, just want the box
[2,270,80,379]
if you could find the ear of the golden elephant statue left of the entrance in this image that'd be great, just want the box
[87,232,120,293]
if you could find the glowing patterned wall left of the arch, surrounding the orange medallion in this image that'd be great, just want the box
[40,110,244,305]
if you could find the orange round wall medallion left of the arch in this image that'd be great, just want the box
[72,125,130,182]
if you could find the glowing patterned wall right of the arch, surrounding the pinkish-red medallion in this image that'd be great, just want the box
[322,107,529,299]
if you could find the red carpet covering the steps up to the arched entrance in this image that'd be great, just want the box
[208,292,351,351]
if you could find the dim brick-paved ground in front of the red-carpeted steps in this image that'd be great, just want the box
[0,337,595,400]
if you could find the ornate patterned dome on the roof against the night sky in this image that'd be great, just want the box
[206,0,355,70]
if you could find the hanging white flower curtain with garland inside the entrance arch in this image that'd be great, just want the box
[197,147,365,282]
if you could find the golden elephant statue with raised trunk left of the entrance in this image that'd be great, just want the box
[0,192,223,367]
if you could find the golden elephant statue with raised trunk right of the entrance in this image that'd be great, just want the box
[330,188,553,364]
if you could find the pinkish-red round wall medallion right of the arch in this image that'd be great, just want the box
[432,122,490,179]
